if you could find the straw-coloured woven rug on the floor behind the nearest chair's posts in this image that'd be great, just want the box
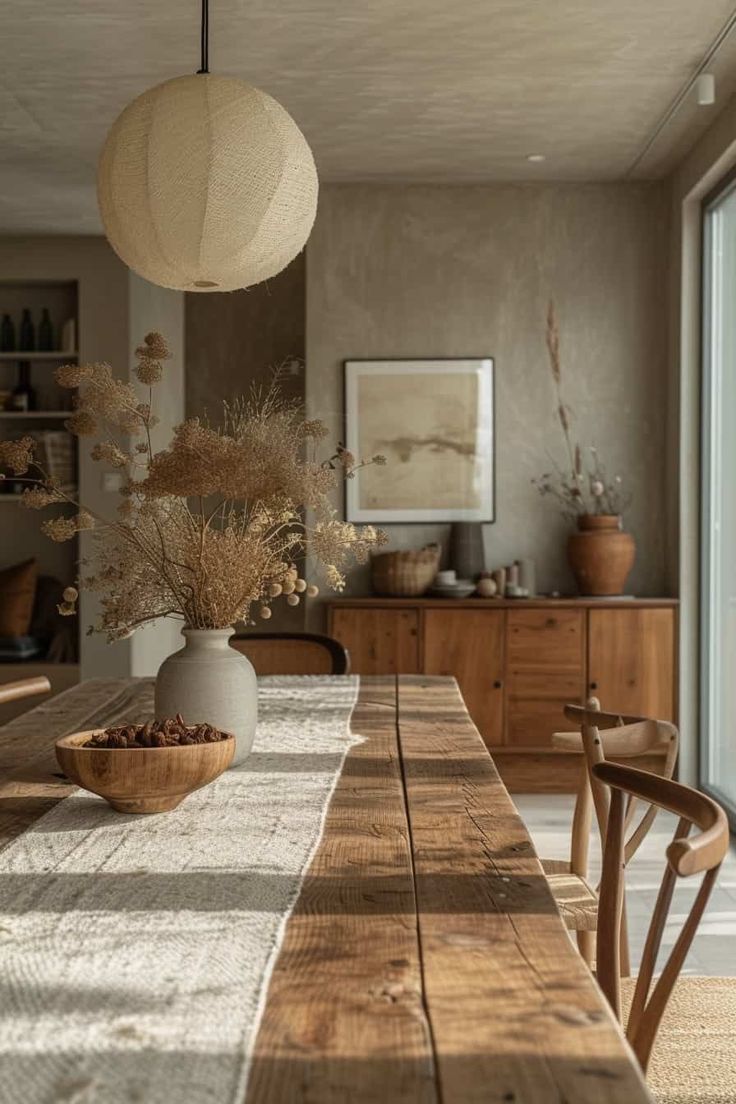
[621,975,736,1104]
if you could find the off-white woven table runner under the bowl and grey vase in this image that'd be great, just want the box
[0,677,358,1104]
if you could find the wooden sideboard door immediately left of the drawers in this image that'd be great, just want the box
[424,609,505,747]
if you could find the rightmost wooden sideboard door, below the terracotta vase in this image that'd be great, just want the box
[588,608,675,721]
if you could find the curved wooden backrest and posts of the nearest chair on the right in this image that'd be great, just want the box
[593,763,729,1072]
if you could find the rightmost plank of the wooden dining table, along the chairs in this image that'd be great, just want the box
[398,678,650,1104]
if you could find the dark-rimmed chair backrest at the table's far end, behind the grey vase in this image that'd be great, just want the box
[230,633,350,675]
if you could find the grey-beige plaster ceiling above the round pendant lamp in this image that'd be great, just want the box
[0,0,736,233]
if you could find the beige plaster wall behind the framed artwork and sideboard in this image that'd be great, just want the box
[307,184,669,609]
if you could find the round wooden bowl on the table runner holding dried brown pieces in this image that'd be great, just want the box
[56,730,235,813]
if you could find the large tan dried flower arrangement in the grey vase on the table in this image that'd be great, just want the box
[0,333,385,640]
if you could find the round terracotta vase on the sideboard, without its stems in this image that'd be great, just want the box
[567,513,637,597]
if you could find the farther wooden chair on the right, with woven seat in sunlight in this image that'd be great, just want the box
[542,698,680,975]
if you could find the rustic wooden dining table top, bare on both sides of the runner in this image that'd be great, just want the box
[0,677,650,1104]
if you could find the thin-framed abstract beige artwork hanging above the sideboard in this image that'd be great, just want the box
[344,357,495,523]
